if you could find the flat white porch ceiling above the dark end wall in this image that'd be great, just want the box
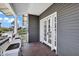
[11,3,53,15]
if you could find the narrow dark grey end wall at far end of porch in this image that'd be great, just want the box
[28,15,39,42]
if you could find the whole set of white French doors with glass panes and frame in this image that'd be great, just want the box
[40,12,57,51]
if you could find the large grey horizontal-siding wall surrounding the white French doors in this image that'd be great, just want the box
[39,3,79,55]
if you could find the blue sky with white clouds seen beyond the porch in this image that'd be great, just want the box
[0,12,22,28]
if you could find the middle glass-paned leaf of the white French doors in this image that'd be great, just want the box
[46,16,52,46]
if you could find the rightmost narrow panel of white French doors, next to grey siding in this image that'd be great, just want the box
[51,12,57,53]
